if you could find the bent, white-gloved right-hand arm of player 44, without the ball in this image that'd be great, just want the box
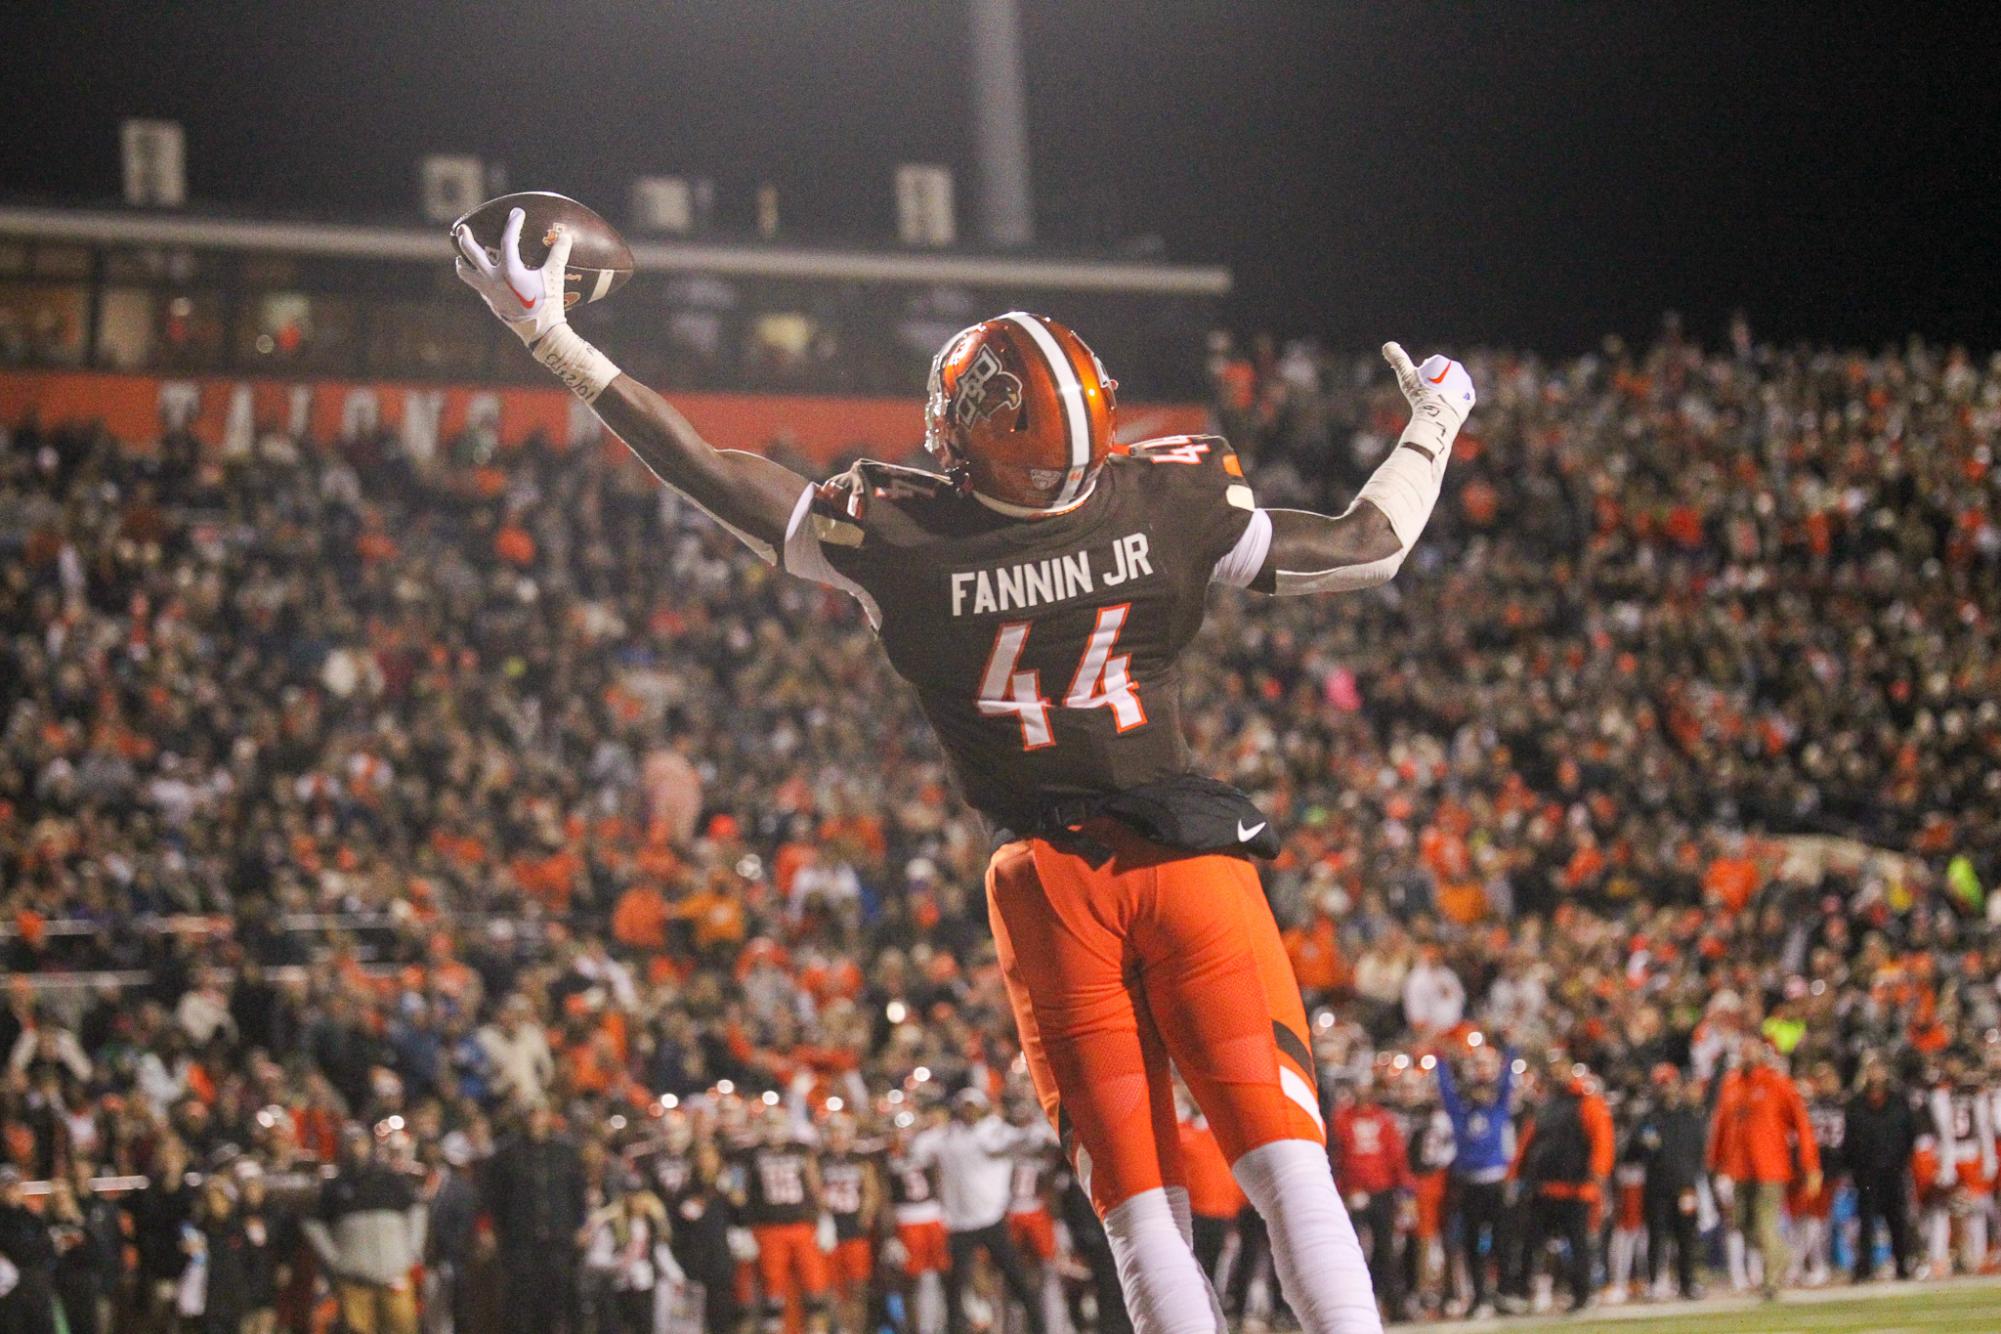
[1219,342,1475,594]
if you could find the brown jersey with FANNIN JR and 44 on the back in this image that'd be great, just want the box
[786,436,1255,830]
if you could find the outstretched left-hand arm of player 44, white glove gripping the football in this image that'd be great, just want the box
[452,208,806,560]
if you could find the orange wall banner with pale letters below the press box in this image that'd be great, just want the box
[0,370,1209,462]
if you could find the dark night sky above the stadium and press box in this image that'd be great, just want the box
[0,0,2001,352]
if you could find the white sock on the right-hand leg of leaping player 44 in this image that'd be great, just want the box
[1231,1140,1383,1334]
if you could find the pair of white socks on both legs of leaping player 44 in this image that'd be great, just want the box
[1105,1140,1383,1334]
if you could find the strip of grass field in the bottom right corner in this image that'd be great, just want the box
[1439,1278,2001,1334]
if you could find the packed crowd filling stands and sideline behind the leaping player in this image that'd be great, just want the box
[0,310,2001,1334]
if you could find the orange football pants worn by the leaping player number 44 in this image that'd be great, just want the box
[986,820,1327,1216]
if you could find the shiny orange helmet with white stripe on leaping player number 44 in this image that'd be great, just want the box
[924,310,1119,518]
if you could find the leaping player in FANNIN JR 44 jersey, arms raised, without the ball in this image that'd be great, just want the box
[456,210,1475,1334]
